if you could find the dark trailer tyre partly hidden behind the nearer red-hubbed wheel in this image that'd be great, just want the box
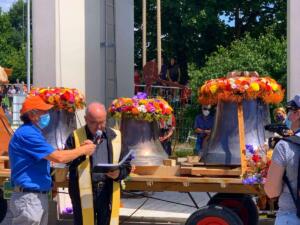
[208,193,259,225]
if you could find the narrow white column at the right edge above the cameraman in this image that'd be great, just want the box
[287,0,300,100]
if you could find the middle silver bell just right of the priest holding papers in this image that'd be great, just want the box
[121,118,168,166]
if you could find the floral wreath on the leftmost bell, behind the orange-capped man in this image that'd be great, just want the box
[29,87,85,112]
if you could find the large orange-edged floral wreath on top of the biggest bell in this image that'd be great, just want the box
[198,71,284,105]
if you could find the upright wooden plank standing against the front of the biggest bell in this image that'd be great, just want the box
[238,102,247,176]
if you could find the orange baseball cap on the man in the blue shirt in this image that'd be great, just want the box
[20,95,53,115]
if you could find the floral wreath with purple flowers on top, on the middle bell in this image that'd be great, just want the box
[108,92,173,122]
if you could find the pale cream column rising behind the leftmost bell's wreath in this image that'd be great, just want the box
[33,0,85,92]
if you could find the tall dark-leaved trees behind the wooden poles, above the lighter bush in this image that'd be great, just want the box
[134,0,286,83]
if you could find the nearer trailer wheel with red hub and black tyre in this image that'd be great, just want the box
[185,205,243,225]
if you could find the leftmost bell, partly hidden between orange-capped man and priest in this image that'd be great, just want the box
[43,109,76,149]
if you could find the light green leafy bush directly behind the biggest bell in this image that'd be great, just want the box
[189,29,287,90]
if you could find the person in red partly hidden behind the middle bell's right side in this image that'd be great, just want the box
[159,114,176,156]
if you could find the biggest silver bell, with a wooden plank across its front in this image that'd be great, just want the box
[202,99,270,165]
